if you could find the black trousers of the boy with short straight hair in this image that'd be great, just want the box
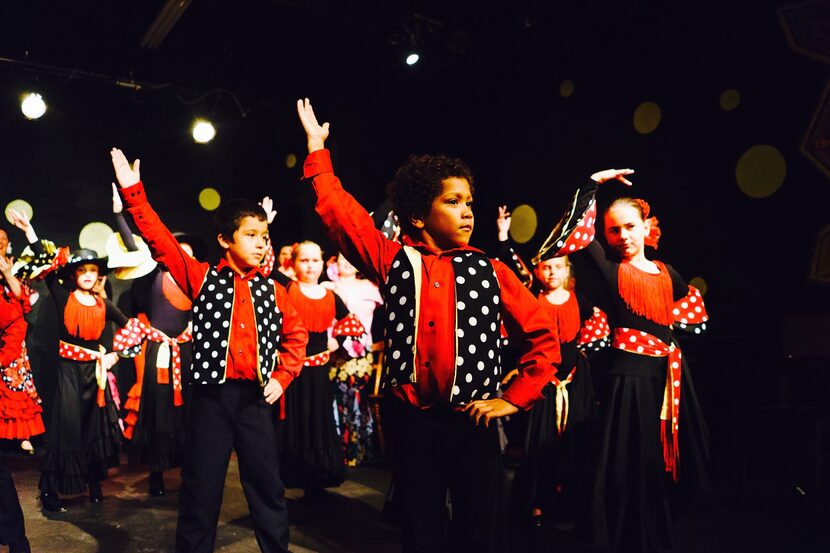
[176,380,288,553]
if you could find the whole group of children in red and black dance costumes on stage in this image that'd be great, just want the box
[0,99,708,552]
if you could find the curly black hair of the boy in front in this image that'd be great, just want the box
[386,154,475,235]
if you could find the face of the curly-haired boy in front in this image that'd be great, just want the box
[412,177,473,250]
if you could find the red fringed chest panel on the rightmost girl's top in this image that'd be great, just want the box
[617,261,674,326]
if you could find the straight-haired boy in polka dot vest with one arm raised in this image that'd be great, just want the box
[111,148,308,553]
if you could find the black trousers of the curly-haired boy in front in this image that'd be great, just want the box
[384,398,506,553]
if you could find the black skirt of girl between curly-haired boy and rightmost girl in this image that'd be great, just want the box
[511,354,597,519]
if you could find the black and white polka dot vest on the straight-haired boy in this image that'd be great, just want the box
[190,267,282,385]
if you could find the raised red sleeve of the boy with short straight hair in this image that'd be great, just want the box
[121,181,210,300]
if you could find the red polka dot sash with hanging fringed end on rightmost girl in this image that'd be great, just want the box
[613,328,682,481]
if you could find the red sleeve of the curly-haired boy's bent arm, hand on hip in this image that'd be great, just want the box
[493,260,562,409]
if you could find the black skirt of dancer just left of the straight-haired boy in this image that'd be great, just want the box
[128,342,191,472]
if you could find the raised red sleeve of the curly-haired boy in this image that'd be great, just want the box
[303,150,402,284]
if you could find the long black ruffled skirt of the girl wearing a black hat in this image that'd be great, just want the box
[39,359,121,494]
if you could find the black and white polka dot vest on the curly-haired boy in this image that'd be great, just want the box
[382,246,501,405]
